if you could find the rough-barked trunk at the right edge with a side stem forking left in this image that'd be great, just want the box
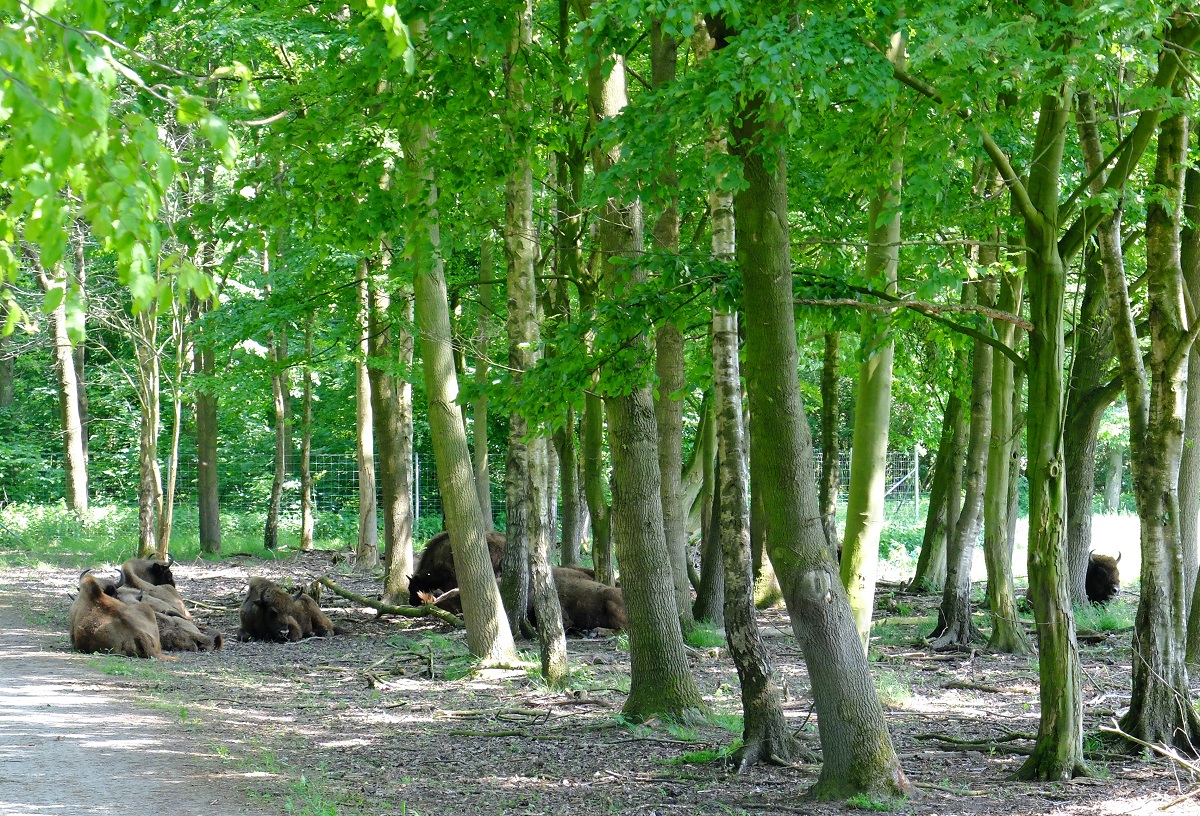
[1100,99,1200,751]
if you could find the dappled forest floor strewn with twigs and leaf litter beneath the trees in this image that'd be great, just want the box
[0,552,1200,816]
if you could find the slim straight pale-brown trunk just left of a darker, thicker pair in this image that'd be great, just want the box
[354,257,379,566]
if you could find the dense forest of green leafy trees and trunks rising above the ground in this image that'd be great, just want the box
[0,0,1200,812]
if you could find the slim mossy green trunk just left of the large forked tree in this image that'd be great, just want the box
[983,259,1031,654]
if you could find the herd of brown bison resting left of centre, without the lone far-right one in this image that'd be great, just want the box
[70,533,626,658]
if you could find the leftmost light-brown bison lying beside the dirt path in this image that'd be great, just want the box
[70,572,163,658]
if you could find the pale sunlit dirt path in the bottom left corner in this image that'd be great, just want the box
[0,588,269,816]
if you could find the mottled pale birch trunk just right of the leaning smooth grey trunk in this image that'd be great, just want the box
[503,0,569,688]
